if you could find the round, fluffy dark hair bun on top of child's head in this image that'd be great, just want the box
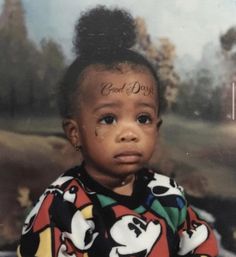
[74,6,136,59]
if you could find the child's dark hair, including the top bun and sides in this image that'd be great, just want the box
[58,6,160,118]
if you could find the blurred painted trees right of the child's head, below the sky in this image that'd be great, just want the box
[136,17,236,121]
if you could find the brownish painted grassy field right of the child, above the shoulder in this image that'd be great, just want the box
[161,116,236,198]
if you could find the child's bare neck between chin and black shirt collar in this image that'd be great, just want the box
[85,164,135,196]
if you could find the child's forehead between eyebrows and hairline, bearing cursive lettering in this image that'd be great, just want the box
[77,64,157,108]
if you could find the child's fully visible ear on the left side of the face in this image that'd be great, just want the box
[62,119,81,147]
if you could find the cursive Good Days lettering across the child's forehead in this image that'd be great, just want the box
[100,81,154,96]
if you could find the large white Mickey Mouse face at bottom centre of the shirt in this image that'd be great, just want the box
[109,215,161,257]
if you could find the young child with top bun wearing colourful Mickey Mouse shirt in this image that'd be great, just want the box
[18,7,217,257]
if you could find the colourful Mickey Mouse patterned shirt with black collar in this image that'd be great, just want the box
[18,165,217,257]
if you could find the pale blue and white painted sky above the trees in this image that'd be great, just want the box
[0,0,236,60]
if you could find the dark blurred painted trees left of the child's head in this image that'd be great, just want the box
[0,1,65,117]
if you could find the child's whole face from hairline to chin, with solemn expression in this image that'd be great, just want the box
[66,67,158,177]
